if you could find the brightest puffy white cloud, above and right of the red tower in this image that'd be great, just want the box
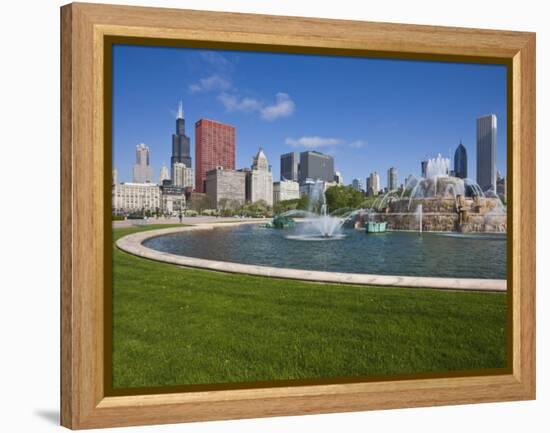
[218,92,296,121]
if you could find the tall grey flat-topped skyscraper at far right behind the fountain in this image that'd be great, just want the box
[476,114,497,191]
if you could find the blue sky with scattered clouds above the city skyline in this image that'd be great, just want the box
[113,45,506,186]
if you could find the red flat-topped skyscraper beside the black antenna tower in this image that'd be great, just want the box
[195,119,235,192]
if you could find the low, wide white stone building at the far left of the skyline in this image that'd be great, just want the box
[112,183,160,213]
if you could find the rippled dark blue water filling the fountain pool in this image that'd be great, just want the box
[144,222,507,278]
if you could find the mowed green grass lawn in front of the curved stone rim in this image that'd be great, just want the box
[113,226,507,388]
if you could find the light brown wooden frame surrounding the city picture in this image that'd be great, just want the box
[61,3,535,429]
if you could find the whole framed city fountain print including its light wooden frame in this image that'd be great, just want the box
[61,3,535,429]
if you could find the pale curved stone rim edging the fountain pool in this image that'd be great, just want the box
[116,221,506,292]
